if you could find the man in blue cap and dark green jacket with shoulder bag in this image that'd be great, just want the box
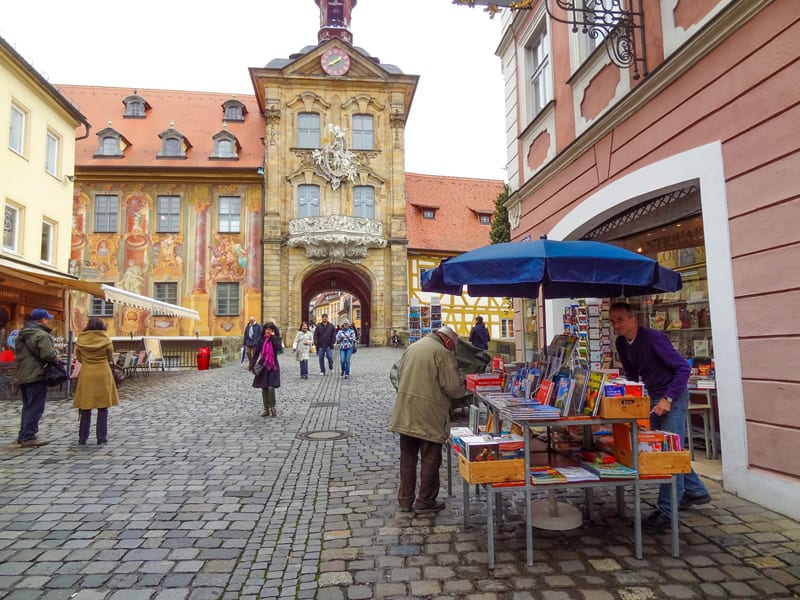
[14,308,58,447]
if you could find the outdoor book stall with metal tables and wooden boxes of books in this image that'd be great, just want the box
[450,334,690,568]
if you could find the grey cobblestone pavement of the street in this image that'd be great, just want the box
[0,348,800,600]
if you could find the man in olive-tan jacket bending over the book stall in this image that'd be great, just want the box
[389,327,466,512]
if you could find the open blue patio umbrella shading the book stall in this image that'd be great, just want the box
[422,239,682,299]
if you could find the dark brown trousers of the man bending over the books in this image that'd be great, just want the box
[397,433,442,508]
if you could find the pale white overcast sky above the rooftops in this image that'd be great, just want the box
[0,0,506,181]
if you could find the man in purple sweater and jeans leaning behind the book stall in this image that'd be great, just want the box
[609,302,711,529]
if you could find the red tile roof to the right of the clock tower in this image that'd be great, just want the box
[406,173,503,254]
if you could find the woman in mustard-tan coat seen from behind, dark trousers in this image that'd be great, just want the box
[72,317,119,444]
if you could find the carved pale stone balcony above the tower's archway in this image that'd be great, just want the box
[286,215,386,264]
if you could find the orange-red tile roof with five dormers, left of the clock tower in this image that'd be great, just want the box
[57,85,265,170]
